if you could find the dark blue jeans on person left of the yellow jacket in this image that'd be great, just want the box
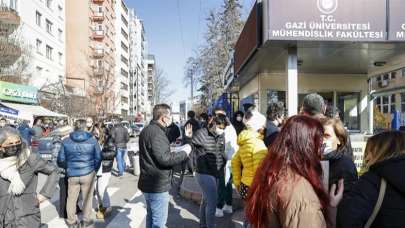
[195,173,218,228]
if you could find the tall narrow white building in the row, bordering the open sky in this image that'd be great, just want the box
[129,10,150,118]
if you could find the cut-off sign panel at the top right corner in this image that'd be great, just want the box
[388,0,405,41]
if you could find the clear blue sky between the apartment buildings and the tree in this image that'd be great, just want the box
[125,0,255,111]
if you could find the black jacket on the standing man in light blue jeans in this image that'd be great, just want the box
[138,121,187,193]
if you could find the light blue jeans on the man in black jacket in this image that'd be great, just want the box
[143,192,170,228]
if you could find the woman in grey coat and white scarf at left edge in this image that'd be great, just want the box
[0,127,59,228]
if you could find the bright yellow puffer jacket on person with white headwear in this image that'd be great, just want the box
[232,129,267,188]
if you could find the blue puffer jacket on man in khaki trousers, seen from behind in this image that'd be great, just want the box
[58,131,101,177]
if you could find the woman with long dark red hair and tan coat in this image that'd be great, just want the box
[246,116,343,228]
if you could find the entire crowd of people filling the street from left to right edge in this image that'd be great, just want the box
[0,91,405,228]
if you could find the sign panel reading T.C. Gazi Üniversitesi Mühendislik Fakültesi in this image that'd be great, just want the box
[267,0,386,42]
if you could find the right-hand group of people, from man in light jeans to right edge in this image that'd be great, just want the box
[138,94,405,228]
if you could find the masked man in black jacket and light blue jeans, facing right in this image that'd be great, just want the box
[138,104,192,228]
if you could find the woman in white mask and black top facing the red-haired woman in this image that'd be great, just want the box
[320,118,358,193]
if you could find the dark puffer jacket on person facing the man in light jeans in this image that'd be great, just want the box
[192,128,226,177]
